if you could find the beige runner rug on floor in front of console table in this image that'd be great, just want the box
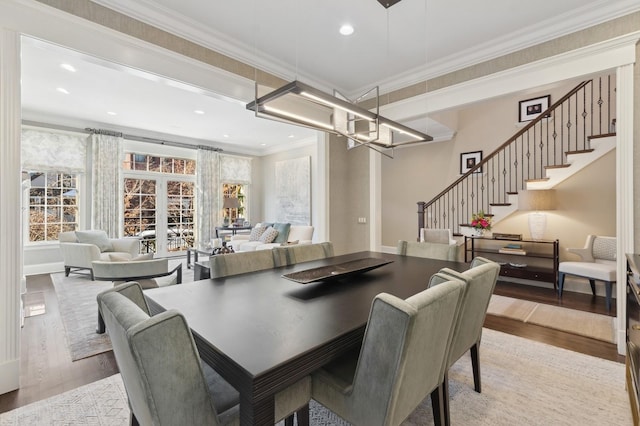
[487,294,615,343]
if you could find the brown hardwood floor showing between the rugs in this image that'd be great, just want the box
[0,275,624,413]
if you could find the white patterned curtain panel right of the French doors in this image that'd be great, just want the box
[196,149,222,243]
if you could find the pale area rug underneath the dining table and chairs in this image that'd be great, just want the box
[0,329,633,426]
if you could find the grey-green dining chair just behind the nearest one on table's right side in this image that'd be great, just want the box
[429,258,500,424]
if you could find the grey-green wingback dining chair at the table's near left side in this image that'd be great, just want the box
[98,283,311,425]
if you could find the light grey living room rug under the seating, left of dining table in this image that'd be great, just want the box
[51,259,193,361]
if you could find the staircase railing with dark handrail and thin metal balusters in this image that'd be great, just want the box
[418,75,615,237]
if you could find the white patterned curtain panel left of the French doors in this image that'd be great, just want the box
[91,134,124,238]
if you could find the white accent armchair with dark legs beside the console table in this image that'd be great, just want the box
[558,235,617,311]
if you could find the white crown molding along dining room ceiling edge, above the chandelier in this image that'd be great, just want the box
[93,0,640,96]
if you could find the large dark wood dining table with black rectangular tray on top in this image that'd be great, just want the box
[145,252,468,425]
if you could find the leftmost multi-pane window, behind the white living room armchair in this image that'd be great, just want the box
[29,172,78,241]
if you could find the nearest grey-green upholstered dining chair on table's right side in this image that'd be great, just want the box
[311,280,464,426]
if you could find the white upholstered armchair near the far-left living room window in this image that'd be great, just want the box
[58,231,140,281]
